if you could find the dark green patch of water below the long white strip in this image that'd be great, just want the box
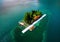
[11,13,48,42]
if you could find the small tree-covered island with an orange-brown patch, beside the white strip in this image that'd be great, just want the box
[19,10,43,31]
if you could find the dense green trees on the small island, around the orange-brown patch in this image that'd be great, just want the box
[24,10,42,24]
